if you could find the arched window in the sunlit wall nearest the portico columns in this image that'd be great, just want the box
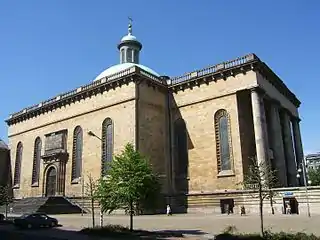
[214,109,232,172]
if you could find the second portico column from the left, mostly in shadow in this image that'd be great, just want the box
[270,101,288,187]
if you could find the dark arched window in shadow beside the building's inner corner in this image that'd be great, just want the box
[174,118,189,177]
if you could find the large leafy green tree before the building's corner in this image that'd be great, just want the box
[97,143,160,231]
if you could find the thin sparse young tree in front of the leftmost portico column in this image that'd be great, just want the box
[242,158,278,235]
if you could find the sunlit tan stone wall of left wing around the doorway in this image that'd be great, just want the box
[9,83,135,198]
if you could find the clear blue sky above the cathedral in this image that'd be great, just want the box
[0,0,320,152]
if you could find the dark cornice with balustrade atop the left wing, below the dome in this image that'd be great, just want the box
[6,66,166,126]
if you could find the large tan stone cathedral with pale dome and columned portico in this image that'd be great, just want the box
[6,22,303,209]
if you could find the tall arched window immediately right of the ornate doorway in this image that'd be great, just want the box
[71,126,83,183]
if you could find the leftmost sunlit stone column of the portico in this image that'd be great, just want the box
[251,88,269,167]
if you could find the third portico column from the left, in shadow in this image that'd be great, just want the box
[281,111,298,187]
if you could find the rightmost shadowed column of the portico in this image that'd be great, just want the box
[292,118,304,186]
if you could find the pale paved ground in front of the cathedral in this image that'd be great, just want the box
[0,213,320,240]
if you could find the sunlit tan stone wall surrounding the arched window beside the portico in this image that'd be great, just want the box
[172,71,257,193]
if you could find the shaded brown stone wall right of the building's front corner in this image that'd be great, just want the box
[137,82,170,192]
